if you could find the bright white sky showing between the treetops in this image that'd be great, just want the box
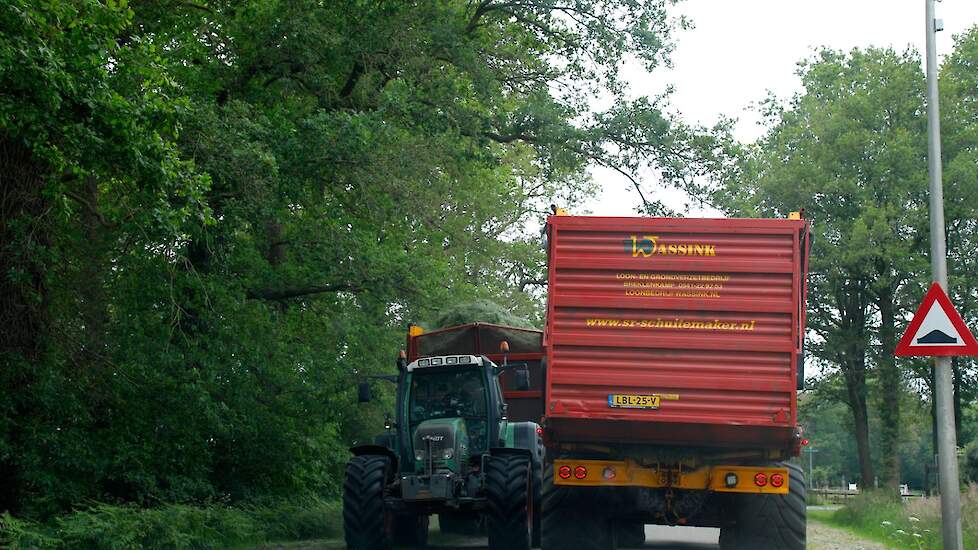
[584,0,978,216]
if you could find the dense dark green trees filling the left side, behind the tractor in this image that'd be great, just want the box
[0,0,722,519]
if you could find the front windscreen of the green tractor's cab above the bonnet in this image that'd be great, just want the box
[409,369,488,451]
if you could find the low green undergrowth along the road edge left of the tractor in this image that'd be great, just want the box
[0,497,342,550]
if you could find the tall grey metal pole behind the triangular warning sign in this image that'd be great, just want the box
[925,0,964,550]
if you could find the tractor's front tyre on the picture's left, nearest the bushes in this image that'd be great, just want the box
[343,455,392,550]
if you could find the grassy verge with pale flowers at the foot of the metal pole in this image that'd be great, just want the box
[808,485,978,550]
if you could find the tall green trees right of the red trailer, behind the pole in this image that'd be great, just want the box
[702,40,978,488]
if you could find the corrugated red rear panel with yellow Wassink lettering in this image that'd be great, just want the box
[545,216,807,454]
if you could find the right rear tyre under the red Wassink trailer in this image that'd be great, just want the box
[720,464,807,550]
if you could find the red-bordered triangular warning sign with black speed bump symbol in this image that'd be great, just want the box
[893,283,978,357]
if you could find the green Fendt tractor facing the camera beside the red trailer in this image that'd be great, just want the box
[343,348,544,550]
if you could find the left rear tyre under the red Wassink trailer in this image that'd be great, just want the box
[540,464,615,550]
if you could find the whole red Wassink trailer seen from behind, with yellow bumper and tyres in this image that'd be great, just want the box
[543,216,809,550]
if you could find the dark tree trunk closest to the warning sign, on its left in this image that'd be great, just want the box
[877,288,903,490]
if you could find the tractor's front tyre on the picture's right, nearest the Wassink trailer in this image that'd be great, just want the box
[486,454,533,550]
